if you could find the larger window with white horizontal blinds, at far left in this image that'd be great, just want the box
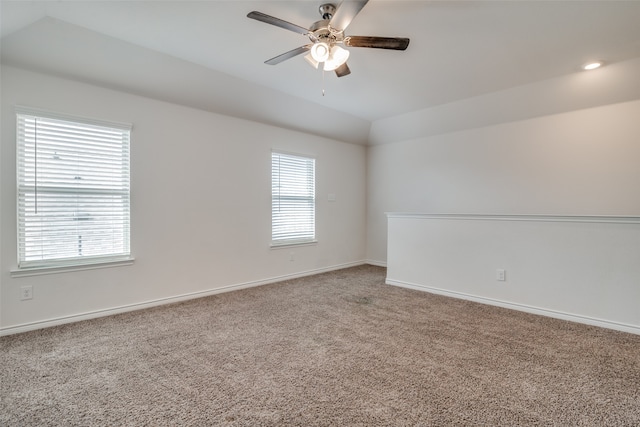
[16,107,131,269]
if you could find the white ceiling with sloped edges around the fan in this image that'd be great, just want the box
[1,0,640,143]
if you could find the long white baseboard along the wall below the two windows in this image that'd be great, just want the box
[0,261,367,336]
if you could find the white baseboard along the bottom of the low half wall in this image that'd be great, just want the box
[385,278,640,335]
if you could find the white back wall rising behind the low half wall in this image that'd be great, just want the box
[367,101,640,264]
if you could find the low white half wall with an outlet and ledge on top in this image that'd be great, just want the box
[387,213,640,334]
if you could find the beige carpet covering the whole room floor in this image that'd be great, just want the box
[0,266,640,426]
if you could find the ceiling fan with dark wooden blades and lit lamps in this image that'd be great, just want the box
[247,0,409,77]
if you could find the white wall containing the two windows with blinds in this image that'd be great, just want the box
[0,66,366,333]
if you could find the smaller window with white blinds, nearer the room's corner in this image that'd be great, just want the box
[271,152,316,246]
